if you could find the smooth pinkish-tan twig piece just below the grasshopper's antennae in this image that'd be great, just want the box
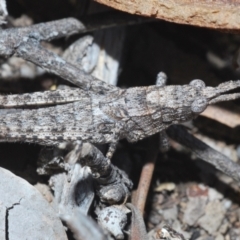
[201,106,240,128]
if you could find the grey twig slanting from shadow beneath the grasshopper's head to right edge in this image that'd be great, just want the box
[167,125,240,182]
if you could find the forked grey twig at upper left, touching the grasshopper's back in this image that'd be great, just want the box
[0,18,118,93]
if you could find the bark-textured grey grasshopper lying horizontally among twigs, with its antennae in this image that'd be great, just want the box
[0,73,240,157]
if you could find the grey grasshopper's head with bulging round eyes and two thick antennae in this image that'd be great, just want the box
[161,79,240,124]
